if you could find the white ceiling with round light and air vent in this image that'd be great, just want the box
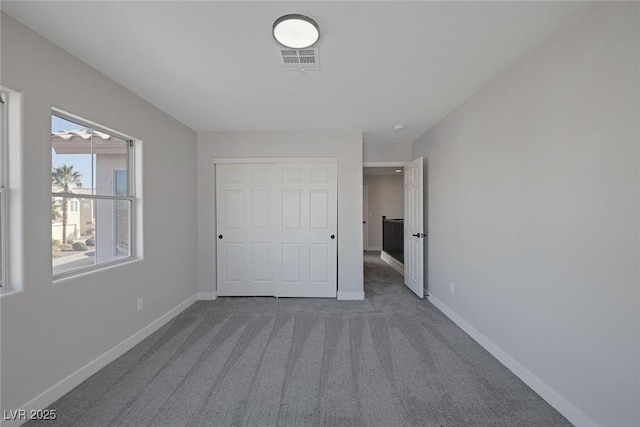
[1,1,588,143]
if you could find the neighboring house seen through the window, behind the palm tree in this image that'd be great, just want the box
[51,129,130,268]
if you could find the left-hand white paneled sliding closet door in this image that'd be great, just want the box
[215,164,277,296]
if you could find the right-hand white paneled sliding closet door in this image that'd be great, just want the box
[274,163,338,298]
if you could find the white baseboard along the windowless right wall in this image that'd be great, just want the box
[427,295,598,427]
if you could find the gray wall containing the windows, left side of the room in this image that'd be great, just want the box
[1,14,197,409]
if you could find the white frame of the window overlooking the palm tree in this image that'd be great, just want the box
[51,107,139,281]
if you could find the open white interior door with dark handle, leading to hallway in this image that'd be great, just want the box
[404,157,425,298]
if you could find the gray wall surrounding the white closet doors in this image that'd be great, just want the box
[198,132,364,298]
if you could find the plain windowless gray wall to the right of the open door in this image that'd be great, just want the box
[413,3,640,426]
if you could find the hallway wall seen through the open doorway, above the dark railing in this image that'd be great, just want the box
[364,174,404,250]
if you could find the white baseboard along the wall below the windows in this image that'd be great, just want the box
[2,295,196,427]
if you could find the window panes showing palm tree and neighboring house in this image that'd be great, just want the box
[51,110,135,278]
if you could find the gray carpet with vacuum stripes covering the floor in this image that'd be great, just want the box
[28,254,570,427]
